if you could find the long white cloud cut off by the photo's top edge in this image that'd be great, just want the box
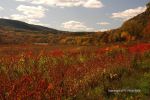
[16,0,103,8]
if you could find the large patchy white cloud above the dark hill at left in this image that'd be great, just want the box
[10,5,47,25]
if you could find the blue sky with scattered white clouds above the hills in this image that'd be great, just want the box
[0,0,149,31]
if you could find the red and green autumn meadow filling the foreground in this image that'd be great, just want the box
[0,42,150,100]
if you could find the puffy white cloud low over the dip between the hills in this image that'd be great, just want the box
[62,21,93,31]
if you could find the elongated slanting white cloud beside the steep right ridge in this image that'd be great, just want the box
[112,7,146,20]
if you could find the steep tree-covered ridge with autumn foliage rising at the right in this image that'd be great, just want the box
[109,3,150,41]
